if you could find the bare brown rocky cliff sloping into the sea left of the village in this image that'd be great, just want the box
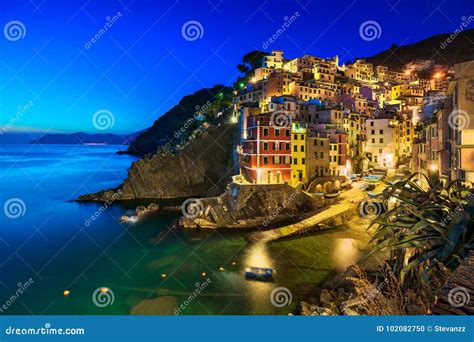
[78,124,237,202]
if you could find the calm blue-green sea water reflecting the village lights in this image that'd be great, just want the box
[0,145,366,315]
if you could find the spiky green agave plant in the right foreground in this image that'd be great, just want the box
[369,174,474,283]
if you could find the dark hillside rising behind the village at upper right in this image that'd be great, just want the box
[362,29,474,70]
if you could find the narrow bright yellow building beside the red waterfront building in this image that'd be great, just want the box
[291,122,308,186]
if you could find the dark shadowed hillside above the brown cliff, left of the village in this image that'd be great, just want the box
[126,85,232,156]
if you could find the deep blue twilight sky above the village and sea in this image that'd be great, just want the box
[0,0,474,133]
